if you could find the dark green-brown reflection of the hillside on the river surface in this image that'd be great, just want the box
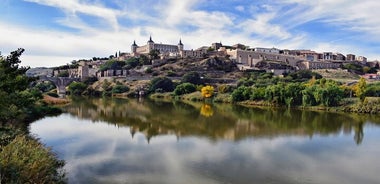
[65,98,380,144]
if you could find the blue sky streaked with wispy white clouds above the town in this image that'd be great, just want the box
[0,0,380,67]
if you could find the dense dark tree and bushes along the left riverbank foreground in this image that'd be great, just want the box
[0,49,65,183]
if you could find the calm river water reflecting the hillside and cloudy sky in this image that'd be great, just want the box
[29,99,380,184]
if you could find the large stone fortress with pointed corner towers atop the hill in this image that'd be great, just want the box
[131,36,206,58]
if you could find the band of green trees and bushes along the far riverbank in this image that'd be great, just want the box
[150,70,380,113]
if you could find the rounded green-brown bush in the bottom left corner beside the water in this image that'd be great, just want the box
[0,135,65,183]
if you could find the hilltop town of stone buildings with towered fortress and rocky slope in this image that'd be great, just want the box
[32,37,380,80]
